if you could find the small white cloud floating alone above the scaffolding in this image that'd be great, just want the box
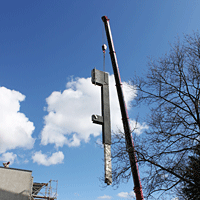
[32,151,64,166]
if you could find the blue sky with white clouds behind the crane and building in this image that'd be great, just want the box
[0,0,200,200]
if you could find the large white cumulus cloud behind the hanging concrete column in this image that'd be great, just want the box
[41,75,147,147]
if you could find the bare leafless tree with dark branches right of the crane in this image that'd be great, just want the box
[109,33,200,199]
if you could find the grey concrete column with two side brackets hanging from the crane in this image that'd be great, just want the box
[92,69,112,185]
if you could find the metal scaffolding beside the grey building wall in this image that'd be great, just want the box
[31,180,58,200]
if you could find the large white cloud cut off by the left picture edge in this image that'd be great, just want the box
[0,87,35,153]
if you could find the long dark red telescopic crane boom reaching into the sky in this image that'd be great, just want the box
[101,16,144,200]
